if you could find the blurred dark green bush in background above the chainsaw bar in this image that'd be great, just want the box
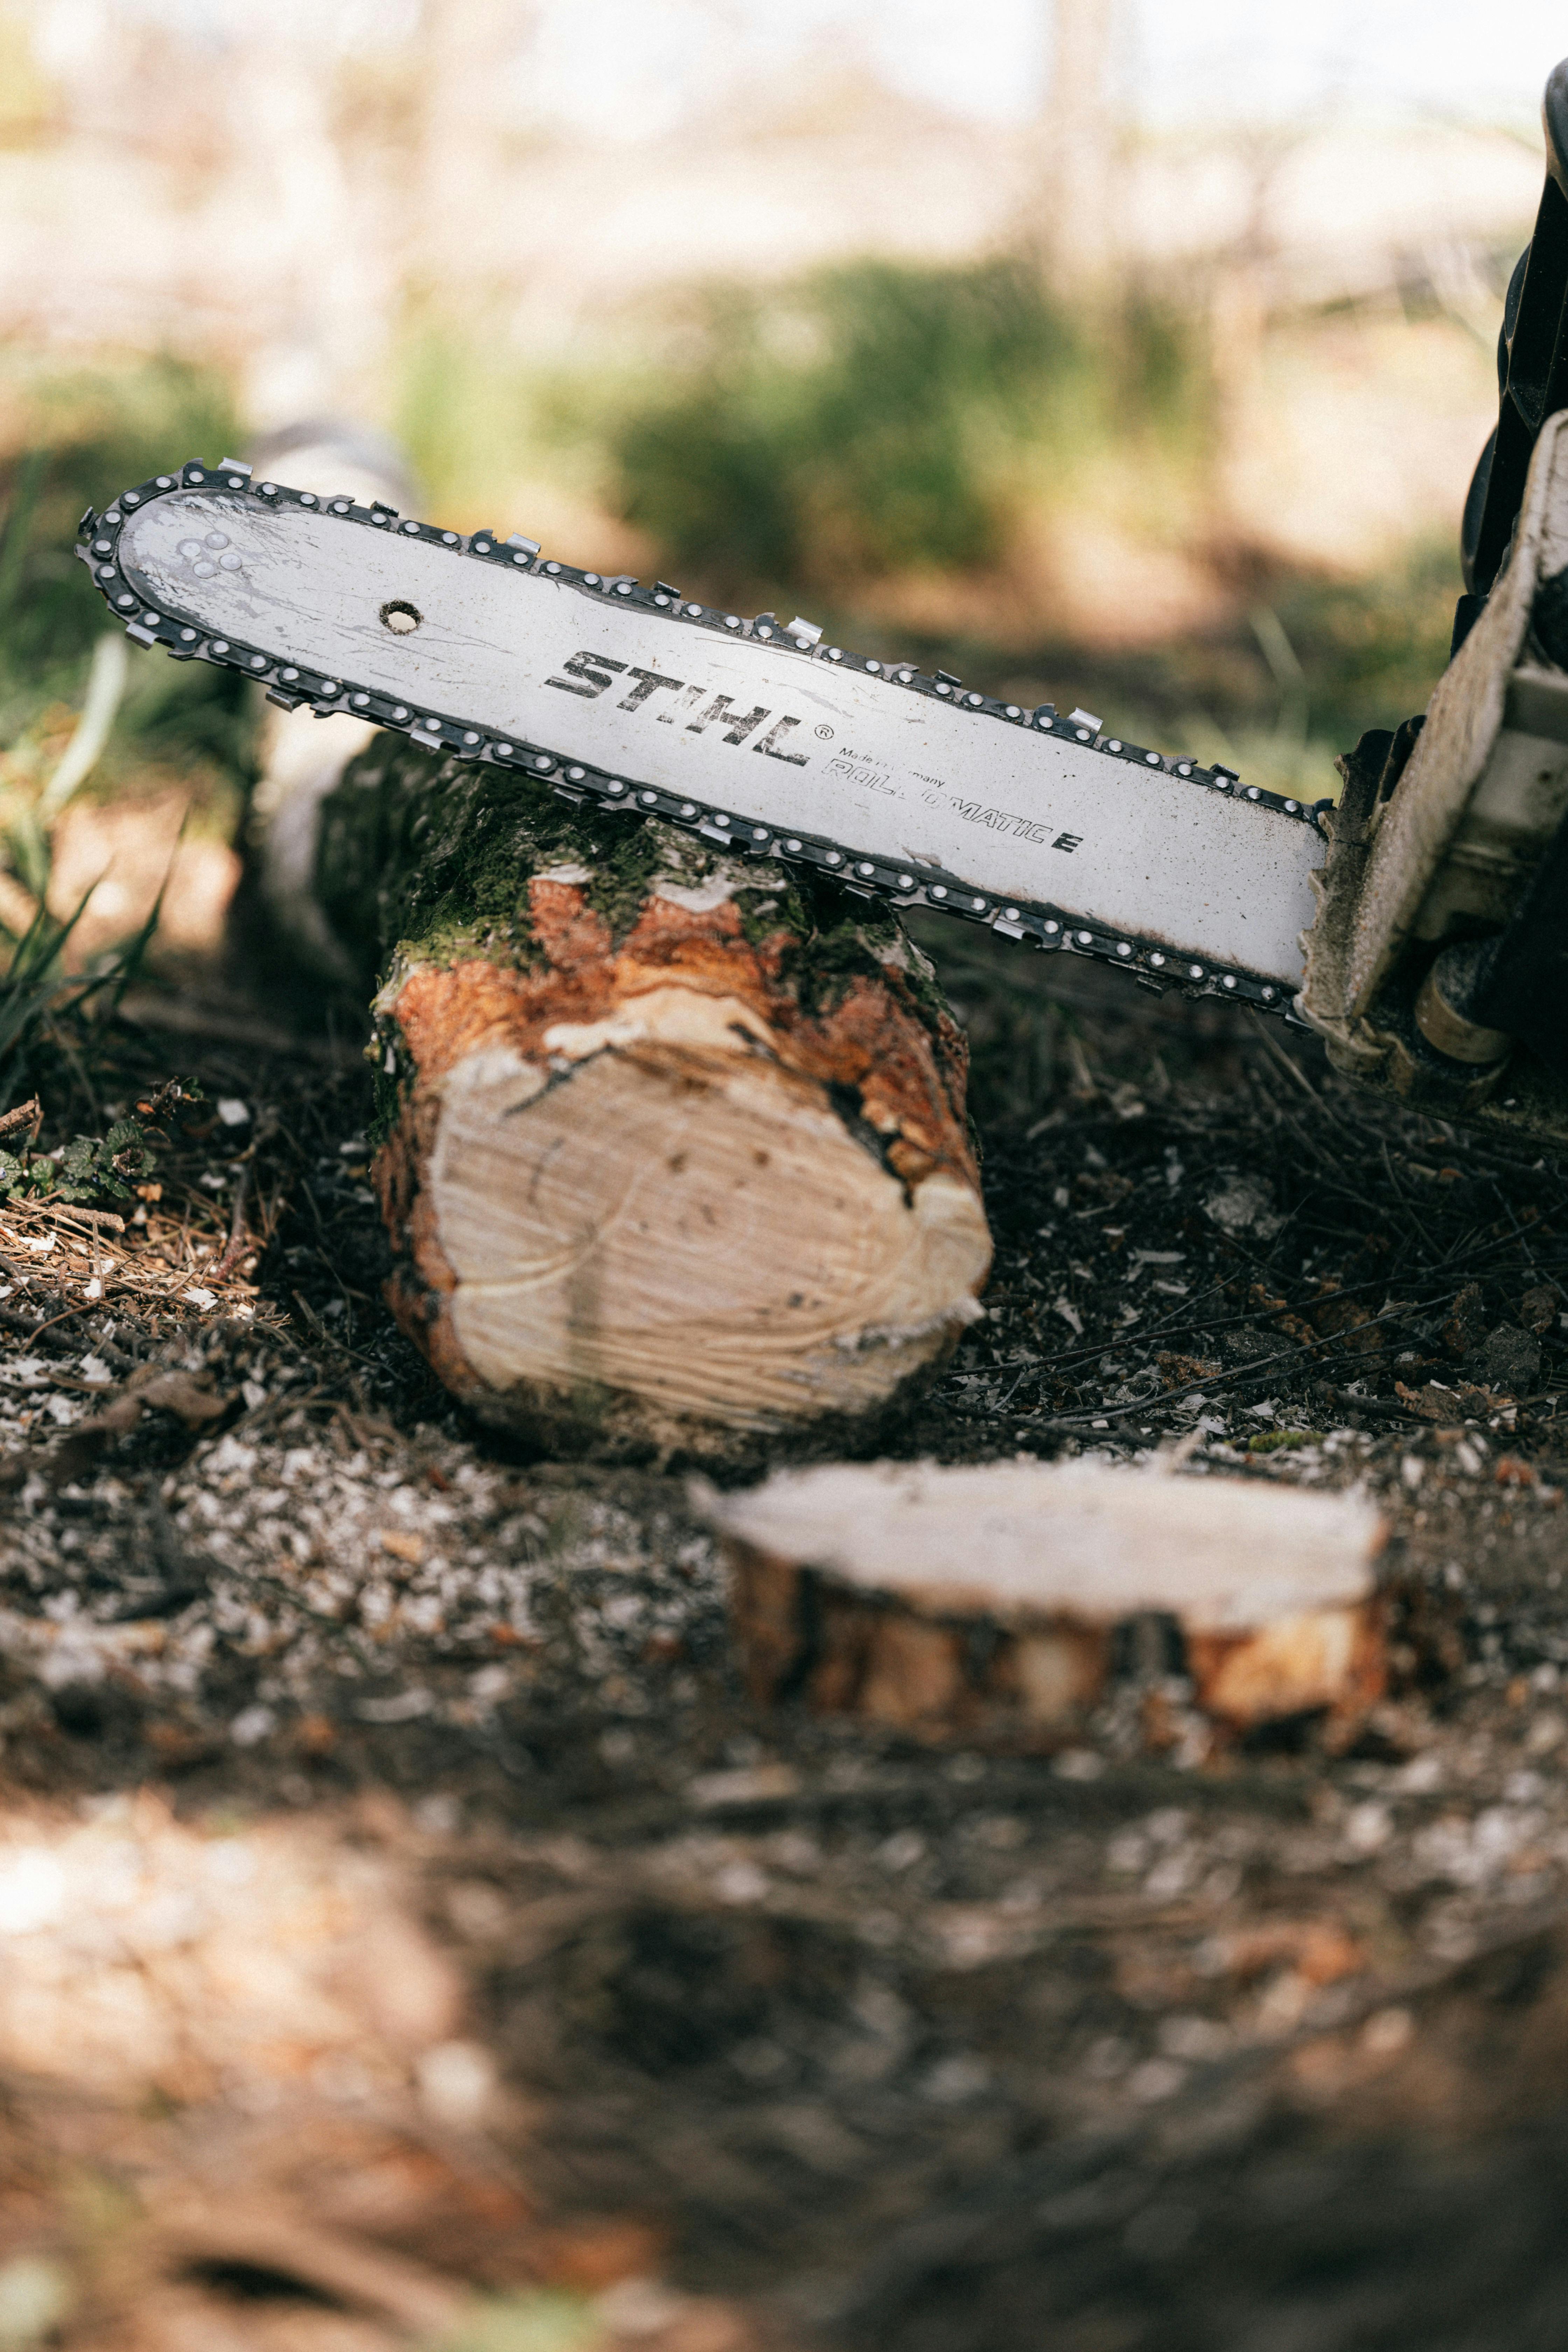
[611,259,1213,595]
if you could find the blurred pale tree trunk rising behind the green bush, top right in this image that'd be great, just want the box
[1039,0,1124,301]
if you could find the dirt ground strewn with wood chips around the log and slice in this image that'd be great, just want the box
[0,936,1568,2352]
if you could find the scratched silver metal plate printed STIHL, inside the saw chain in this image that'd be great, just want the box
[120,489,1323,988]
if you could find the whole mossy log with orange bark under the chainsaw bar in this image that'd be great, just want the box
[288,729,990,1458]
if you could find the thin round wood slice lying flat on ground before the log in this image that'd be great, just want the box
[696,1461,1385,1748]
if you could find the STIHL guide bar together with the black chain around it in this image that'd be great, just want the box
[80,461,1323,1011]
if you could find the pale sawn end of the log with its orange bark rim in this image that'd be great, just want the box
[376,870,990,1458]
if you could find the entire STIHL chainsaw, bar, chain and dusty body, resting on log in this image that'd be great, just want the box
[78,61,1568,1143]
